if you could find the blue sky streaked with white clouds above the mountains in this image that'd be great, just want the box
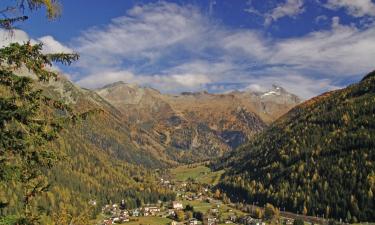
[0,0,375,99]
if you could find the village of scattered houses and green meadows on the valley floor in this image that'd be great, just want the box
[98,163,323,225]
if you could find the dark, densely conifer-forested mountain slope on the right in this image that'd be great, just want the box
[216,72,375,222]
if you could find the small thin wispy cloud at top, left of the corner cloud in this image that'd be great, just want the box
[265,0,304,25]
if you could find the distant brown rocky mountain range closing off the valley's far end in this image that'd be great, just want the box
[96,82,300,162]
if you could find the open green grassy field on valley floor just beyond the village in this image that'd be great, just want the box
[171,165,224,185]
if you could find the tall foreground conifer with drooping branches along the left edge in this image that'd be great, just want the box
[0,0,78,224]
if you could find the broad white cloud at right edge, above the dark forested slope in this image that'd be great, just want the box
[269,18,375,77]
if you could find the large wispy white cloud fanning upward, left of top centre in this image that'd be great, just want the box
[76,2,210,71]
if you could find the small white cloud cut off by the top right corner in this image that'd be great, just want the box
[325,0,375,17]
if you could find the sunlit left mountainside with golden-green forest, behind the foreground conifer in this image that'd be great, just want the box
[0,71,175,221]
